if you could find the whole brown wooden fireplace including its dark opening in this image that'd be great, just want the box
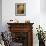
[7,23,33,46]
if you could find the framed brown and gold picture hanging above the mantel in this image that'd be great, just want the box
[15,3,26,16]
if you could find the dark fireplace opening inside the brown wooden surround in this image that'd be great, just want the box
[12,32,28,46]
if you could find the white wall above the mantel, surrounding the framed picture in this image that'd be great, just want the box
[2,0,40,31]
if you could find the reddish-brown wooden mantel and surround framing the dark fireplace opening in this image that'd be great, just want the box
[7,23,33,46]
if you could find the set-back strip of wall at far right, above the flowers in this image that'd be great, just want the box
[40,0,46,31]
